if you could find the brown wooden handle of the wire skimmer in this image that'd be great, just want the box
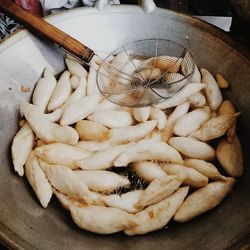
[0,0,94,62]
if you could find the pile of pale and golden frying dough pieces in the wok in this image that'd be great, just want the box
[12,53,243,235]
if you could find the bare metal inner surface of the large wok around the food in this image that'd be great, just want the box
[0,2,250,250]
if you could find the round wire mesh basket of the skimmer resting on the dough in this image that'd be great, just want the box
[94,39,194,107]
